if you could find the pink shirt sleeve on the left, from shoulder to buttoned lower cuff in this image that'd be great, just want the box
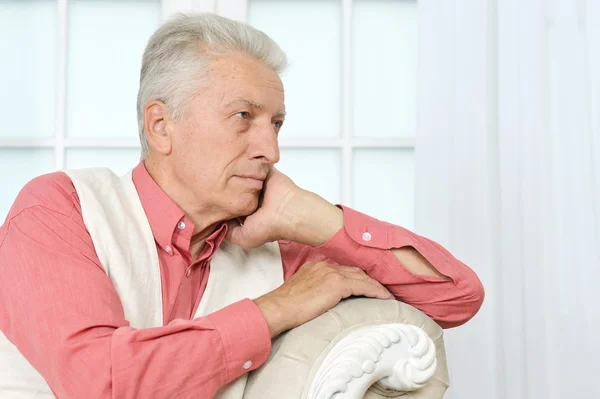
[0,179,271,398]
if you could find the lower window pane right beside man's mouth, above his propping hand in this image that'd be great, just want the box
[276,148,342,204]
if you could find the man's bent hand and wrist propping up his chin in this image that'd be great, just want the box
[227,168,343,248]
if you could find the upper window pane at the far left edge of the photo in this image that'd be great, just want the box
[0,0,57,138]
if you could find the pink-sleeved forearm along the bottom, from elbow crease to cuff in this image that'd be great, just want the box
[111,300,270,398]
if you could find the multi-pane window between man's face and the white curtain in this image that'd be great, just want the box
[247,0,417,228]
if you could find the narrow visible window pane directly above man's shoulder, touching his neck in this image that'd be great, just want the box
[65,148,140,176]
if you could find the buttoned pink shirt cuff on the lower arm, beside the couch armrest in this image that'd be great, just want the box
[207,299,271,384]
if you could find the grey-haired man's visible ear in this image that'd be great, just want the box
[144,100,172,155]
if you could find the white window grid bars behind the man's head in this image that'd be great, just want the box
[0,0,415,206]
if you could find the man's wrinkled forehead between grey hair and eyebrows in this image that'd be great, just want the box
[209,56,284,107]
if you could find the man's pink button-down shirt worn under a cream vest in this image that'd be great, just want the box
[0,163,484,398]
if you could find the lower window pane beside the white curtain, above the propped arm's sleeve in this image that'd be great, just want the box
[352,149,415,229]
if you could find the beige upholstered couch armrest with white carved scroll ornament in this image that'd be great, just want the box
[244,298,449,399]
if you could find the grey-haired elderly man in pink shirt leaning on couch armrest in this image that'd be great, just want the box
[0,15,483,399]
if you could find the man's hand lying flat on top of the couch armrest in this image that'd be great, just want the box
[254,262,394,337]
